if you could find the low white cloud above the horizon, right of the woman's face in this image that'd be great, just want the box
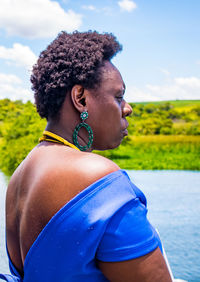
[125,77,200,102]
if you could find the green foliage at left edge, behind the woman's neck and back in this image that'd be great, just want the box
[0,99,45,175]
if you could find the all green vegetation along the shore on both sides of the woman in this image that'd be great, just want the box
[0,99,200,175]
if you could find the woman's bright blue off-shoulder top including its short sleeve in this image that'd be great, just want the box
[0,170,162,282]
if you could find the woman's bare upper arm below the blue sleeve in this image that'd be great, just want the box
[98,248,172,282]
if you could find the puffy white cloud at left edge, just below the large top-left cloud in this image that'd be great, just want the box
[0,43,37,70]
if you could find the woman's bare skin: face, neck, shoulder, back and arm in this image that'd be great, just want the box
[6,62,171,282]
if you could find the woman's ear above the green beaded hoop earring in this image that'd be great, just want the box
[71,85,86,113]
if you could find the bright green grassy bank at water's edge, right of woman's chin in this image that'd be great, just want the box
[95,135,200,170]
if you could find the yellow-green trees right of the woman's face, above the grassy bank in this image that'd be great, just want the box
[129,101,200,135]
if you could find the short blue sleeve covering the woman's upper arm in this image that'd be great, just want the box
[96,195,161,262]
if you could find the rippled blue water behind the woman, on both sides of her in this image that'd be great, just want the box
[0,170,200,282]
